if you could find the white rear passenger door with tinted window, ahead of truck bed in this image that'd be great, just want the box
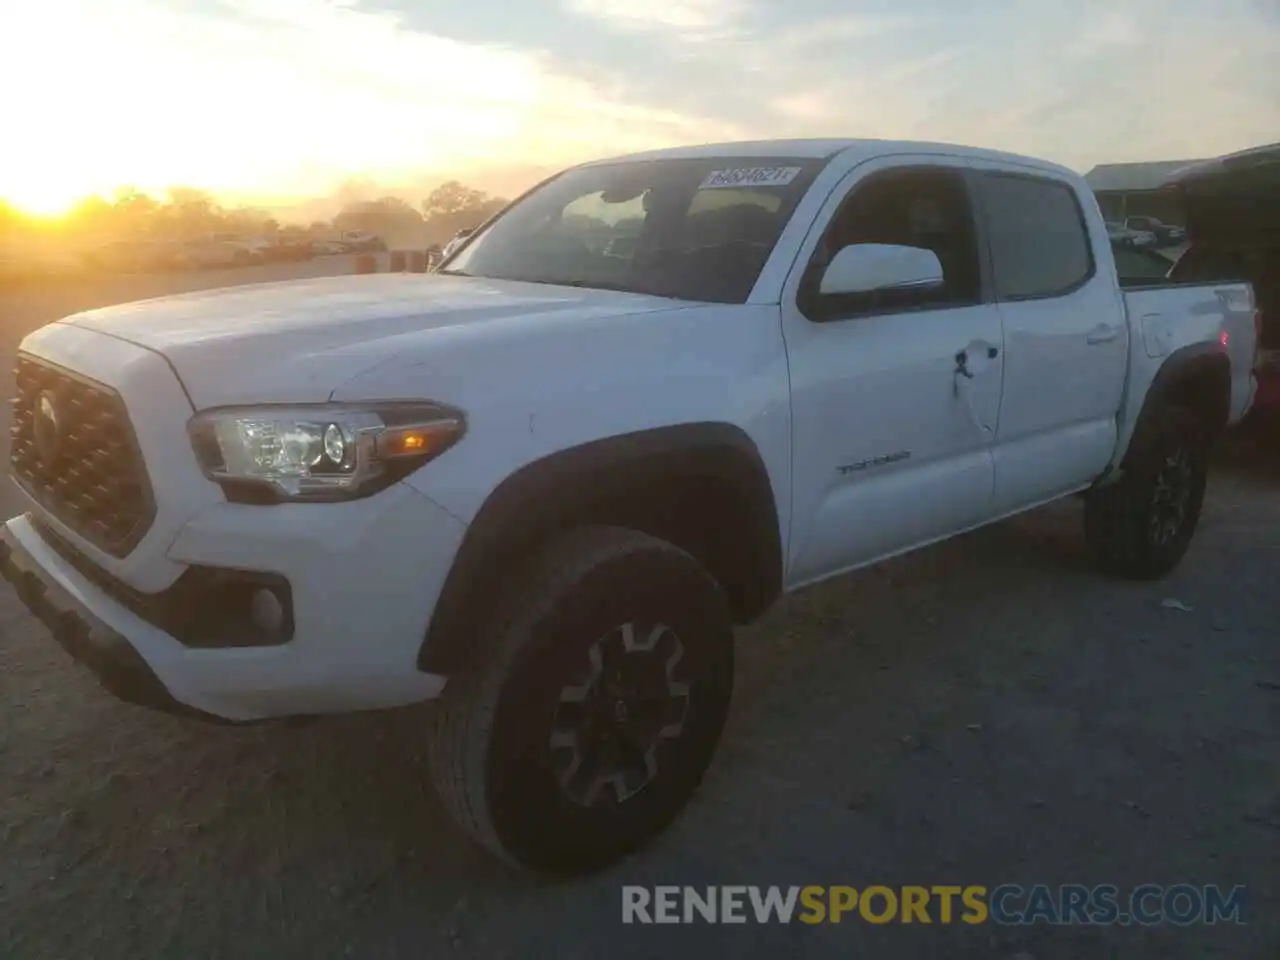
[974,161,1129,513]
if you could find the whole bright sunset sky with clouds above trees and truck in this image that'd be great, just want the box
[0,0,1280,212]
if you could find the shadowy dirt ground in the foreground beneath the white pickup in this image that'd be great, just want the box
[0,272,1280,960]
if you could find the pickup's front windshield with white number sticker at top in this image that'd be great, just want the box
[440,157,826,303]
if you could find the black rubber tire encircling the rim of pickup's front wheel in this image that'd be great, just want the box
[430,527,733,874]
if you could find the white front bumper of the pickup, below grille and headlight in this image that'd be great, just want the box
[0,484,465,722]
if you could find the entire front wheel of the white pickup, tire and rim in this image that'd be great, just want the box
[431,527,733,873]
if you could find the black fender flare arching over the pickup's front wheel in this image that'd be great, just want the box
[417,422,783,675]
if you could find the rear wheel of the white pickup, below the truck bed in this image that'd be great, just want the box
[1084,407,1212,580]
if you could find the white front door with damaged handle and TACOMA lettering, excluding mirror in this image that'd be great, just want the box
[782,156,1004,586]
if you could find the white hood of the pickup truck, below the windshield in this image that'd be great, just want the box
[60,274,672,410]
